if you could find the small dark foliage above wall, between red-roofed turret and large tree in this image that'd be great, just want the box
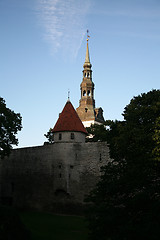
[86,124,107,142]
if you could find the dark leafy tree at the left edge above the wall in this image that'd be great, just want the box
[0,98,22,157]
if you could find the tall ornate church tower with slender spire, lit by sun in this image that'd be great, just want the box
[76,31,104,127]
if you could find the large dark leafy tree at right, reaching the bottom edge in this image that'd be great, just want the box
[87,90,160,240]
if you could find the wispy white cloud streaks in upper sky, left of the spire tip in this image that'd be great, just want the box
[37,0,90,57]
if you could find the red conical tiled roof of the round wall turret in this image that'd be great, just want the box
[52,101,87,134]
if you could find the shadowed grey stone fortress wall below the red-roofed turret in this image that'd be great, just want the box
[0,142,109,211]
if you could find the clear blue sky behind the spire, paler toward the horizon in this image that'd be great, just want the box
[0,0,160,147]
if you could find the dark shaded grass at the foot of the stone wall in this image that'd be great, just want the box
[20,212,87,240]
